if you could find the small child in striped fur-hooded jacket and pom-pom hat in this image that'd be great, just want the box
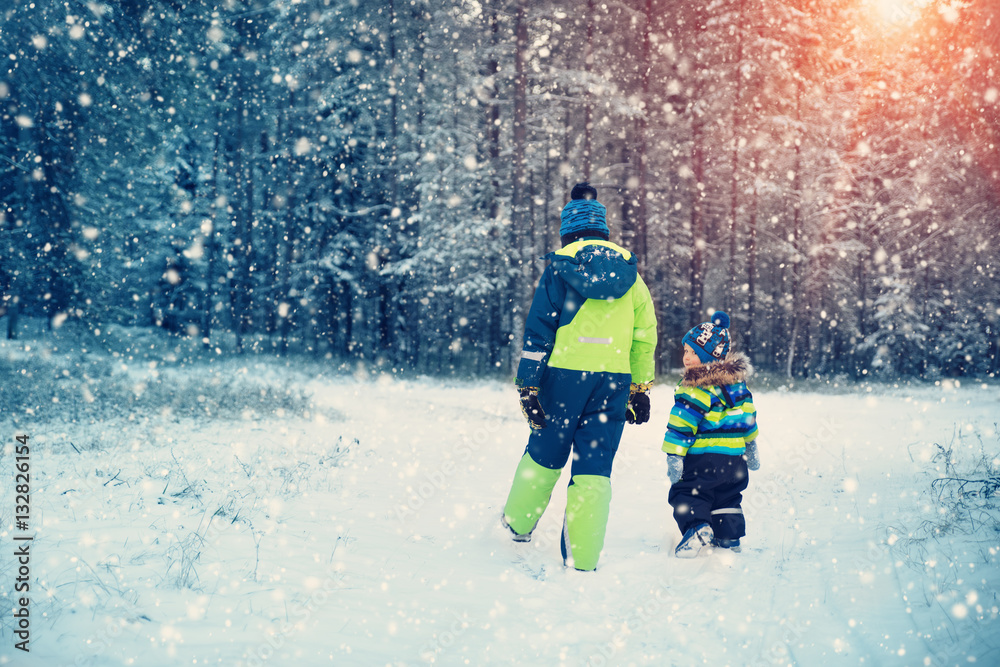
[663,311,760,558]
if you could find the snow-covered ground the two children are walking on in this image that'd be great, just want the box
[0,334,1000,667]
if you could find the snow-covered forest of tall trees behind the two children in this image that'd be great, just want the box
[0,0,1000,379]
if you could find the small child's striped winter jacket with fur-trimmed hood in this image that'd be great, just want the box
[663,352,757,456]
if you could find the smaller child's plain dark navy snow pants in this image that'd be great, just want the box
[667,453,750,540]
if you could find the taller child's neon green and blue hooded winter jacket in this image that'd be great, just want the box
[515,238,656,387]
